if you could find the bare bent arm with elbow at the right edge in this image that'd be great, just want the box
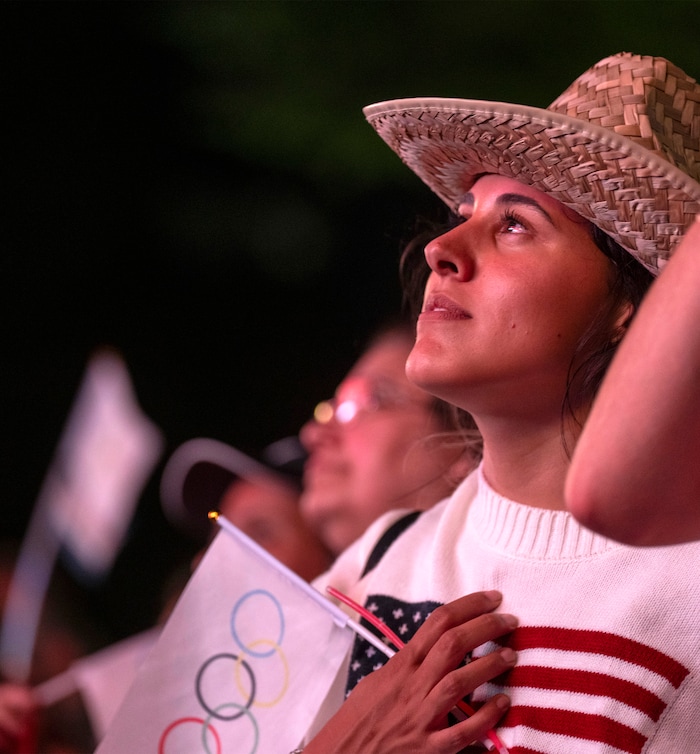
[566,216,700,544]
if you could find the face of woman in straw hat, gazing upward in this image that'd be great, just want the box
[407,175,611,420]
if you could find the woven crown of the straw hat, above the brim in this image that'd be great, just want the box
[547,53,700,180]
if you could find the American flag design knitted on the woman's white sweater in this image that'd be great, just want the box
[347,595,692,754]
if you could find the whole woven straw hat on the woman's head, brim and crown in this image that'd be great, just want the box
[364,52,700,273]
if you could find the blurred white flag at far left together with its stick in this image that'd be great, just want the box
[0,350,163,681]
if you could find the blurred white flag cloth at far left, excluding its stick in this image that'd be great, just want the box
[47,351,162,576]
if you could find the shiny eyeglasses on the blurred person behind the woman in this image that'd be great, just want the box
[314,377,428,424]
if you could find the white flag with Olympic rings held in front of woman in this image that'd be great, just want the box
[96,519,353,754]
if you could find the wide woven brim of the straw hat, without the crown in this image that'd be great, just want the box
[363,97,700,274]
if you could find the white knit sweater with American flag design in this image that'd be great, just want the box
[316,469,700,754]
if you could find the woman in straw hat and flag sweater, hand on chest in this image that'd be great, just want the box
[304,53,700,754]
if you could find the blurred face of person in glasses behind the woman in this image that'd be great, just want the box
[300,323,471,554]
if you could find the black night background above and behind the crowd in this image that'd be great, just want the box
[0,0,700,640]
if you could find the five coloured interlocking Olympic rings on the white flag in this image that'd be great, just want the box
[158,589,289,754]
